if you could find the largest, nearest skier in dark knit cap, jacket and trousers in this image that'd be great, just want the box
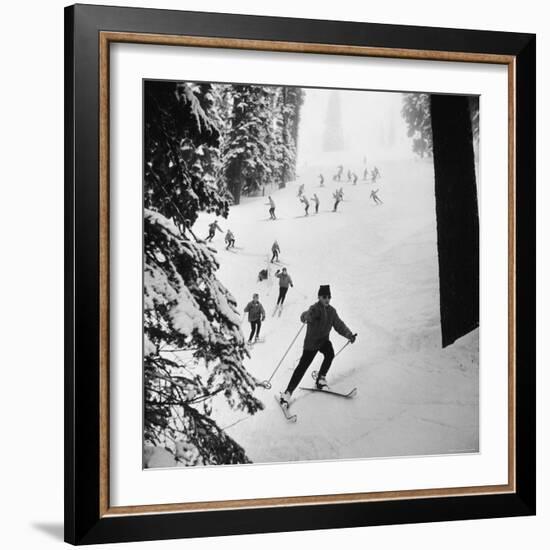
[279,285,356,407]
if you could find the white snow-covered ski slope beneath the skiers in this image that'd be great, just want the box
[194,161,479,463]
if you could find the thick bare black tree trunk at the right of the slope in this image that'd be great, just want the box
[430,95,479,347]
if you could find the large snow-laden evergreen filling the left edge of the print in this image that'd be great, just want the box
[144,82,263,465]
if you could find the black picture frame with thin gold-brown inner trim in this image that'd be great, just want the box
[65,5,536,544]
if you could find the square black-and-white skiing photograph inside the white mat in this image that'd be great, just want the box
[143,80,479,468]
